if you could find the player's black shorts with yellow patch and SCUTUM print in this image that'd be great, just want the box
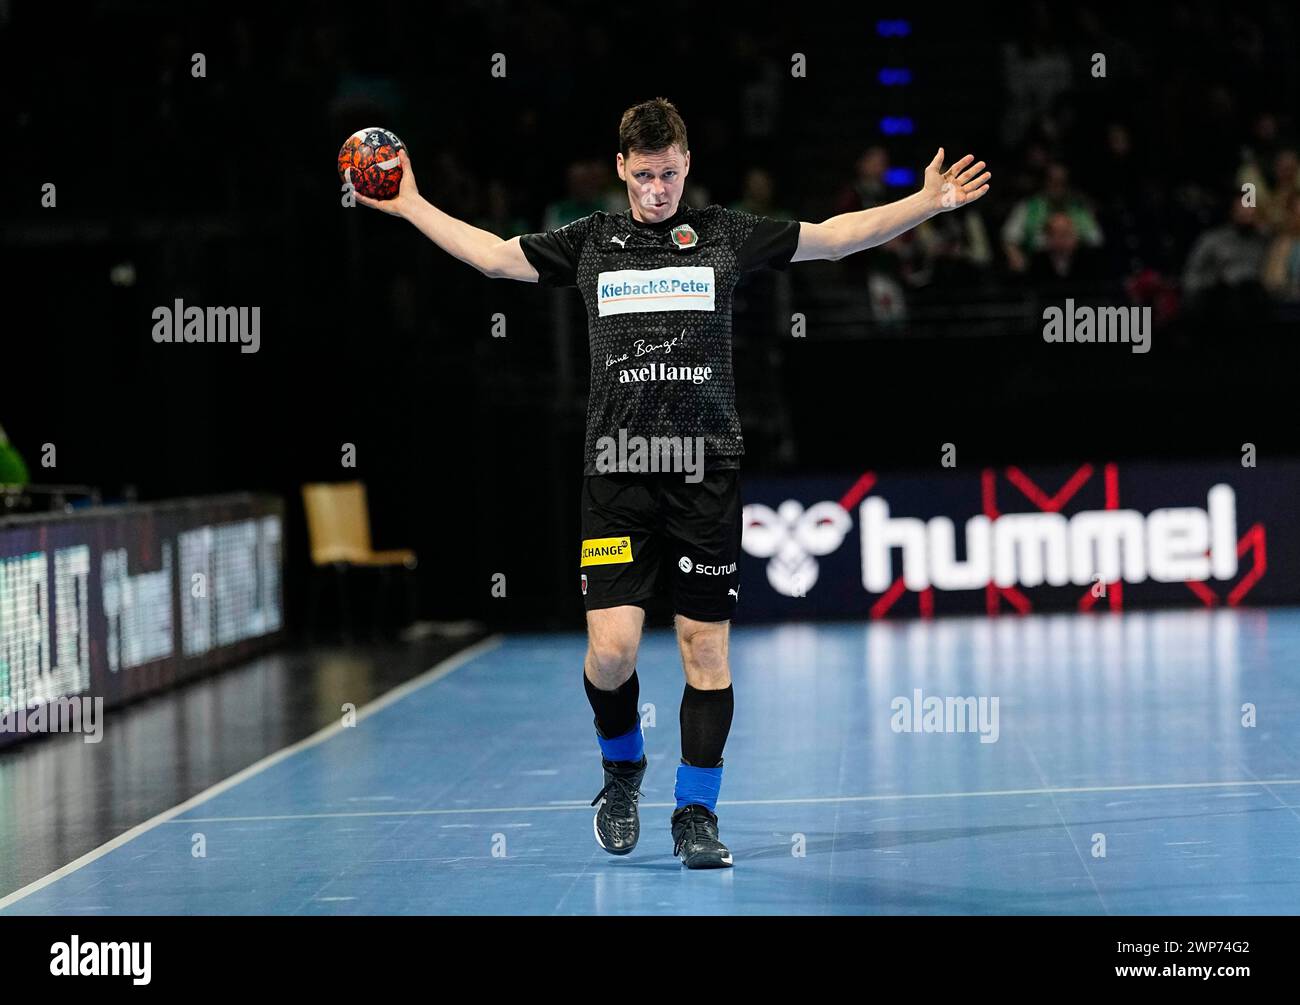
[580,469,741,621]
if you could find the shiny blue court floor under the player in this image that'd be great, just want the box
[3,610,1300,914]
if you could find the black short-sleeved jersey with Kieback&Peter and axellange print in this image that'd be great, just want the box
[519,205,800,475]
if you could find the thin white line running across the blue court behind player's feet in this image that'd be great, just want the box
[162,779,1300,821]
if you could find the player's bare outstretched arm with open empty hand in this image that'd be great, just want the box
[790,147,993,261]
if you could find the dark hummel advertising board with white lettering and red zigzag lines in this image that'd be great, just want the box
[737,462,1300,620]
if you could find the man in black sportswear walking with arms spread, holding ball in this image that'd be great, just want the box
[356,98,991,868]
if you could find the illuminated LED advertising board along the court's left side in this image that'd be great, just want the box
[0,495,283,745]
